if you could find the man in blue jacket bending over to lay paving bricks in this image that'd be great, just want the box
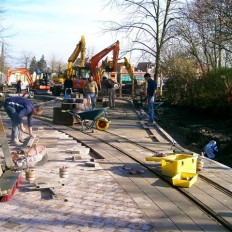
[4,97,43,146]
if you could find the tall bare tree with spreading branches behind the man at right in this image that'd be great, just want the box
[103,0,179,79]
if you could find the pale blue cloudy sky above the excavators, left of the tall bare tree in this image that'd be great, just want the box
[1,0,119,68]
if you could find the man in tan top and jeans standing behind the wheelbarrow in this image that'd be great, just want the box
[83,76,98,110]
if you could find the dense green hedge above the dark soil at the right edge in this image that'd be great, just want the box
[164,68,232,114]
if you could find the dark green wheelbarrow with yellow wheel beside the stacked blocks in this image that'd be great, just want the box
[69,107,110,131]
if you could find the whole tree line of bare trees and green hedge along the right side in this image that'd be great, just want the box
[103,0,232,114]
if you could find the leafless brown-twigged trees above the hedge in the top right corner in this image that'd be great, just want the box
[178,0,232,72]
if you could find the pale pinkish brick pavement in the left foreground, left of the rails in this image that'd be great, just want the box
[0,115,156,232]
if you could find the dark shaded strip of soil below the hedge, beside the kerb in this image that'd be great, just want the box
[156,104,232,167]
